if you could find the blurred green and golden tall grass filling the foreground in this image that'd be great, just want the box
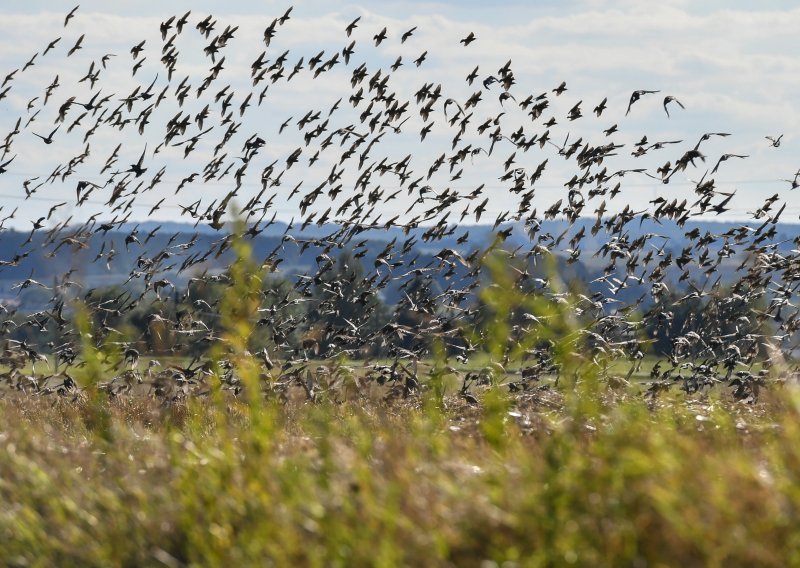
[0,233,800,566]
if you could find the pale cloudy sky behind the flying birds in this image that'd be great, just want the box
[0,0,800,229]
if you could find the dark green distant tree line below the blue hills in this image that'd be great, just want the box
[0,250,776,368]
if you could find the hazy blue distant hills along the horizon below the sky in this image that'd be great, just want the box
[0,218,800,310]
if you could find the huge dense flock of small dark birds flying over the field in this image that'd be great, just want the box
[0,7,800,401]
